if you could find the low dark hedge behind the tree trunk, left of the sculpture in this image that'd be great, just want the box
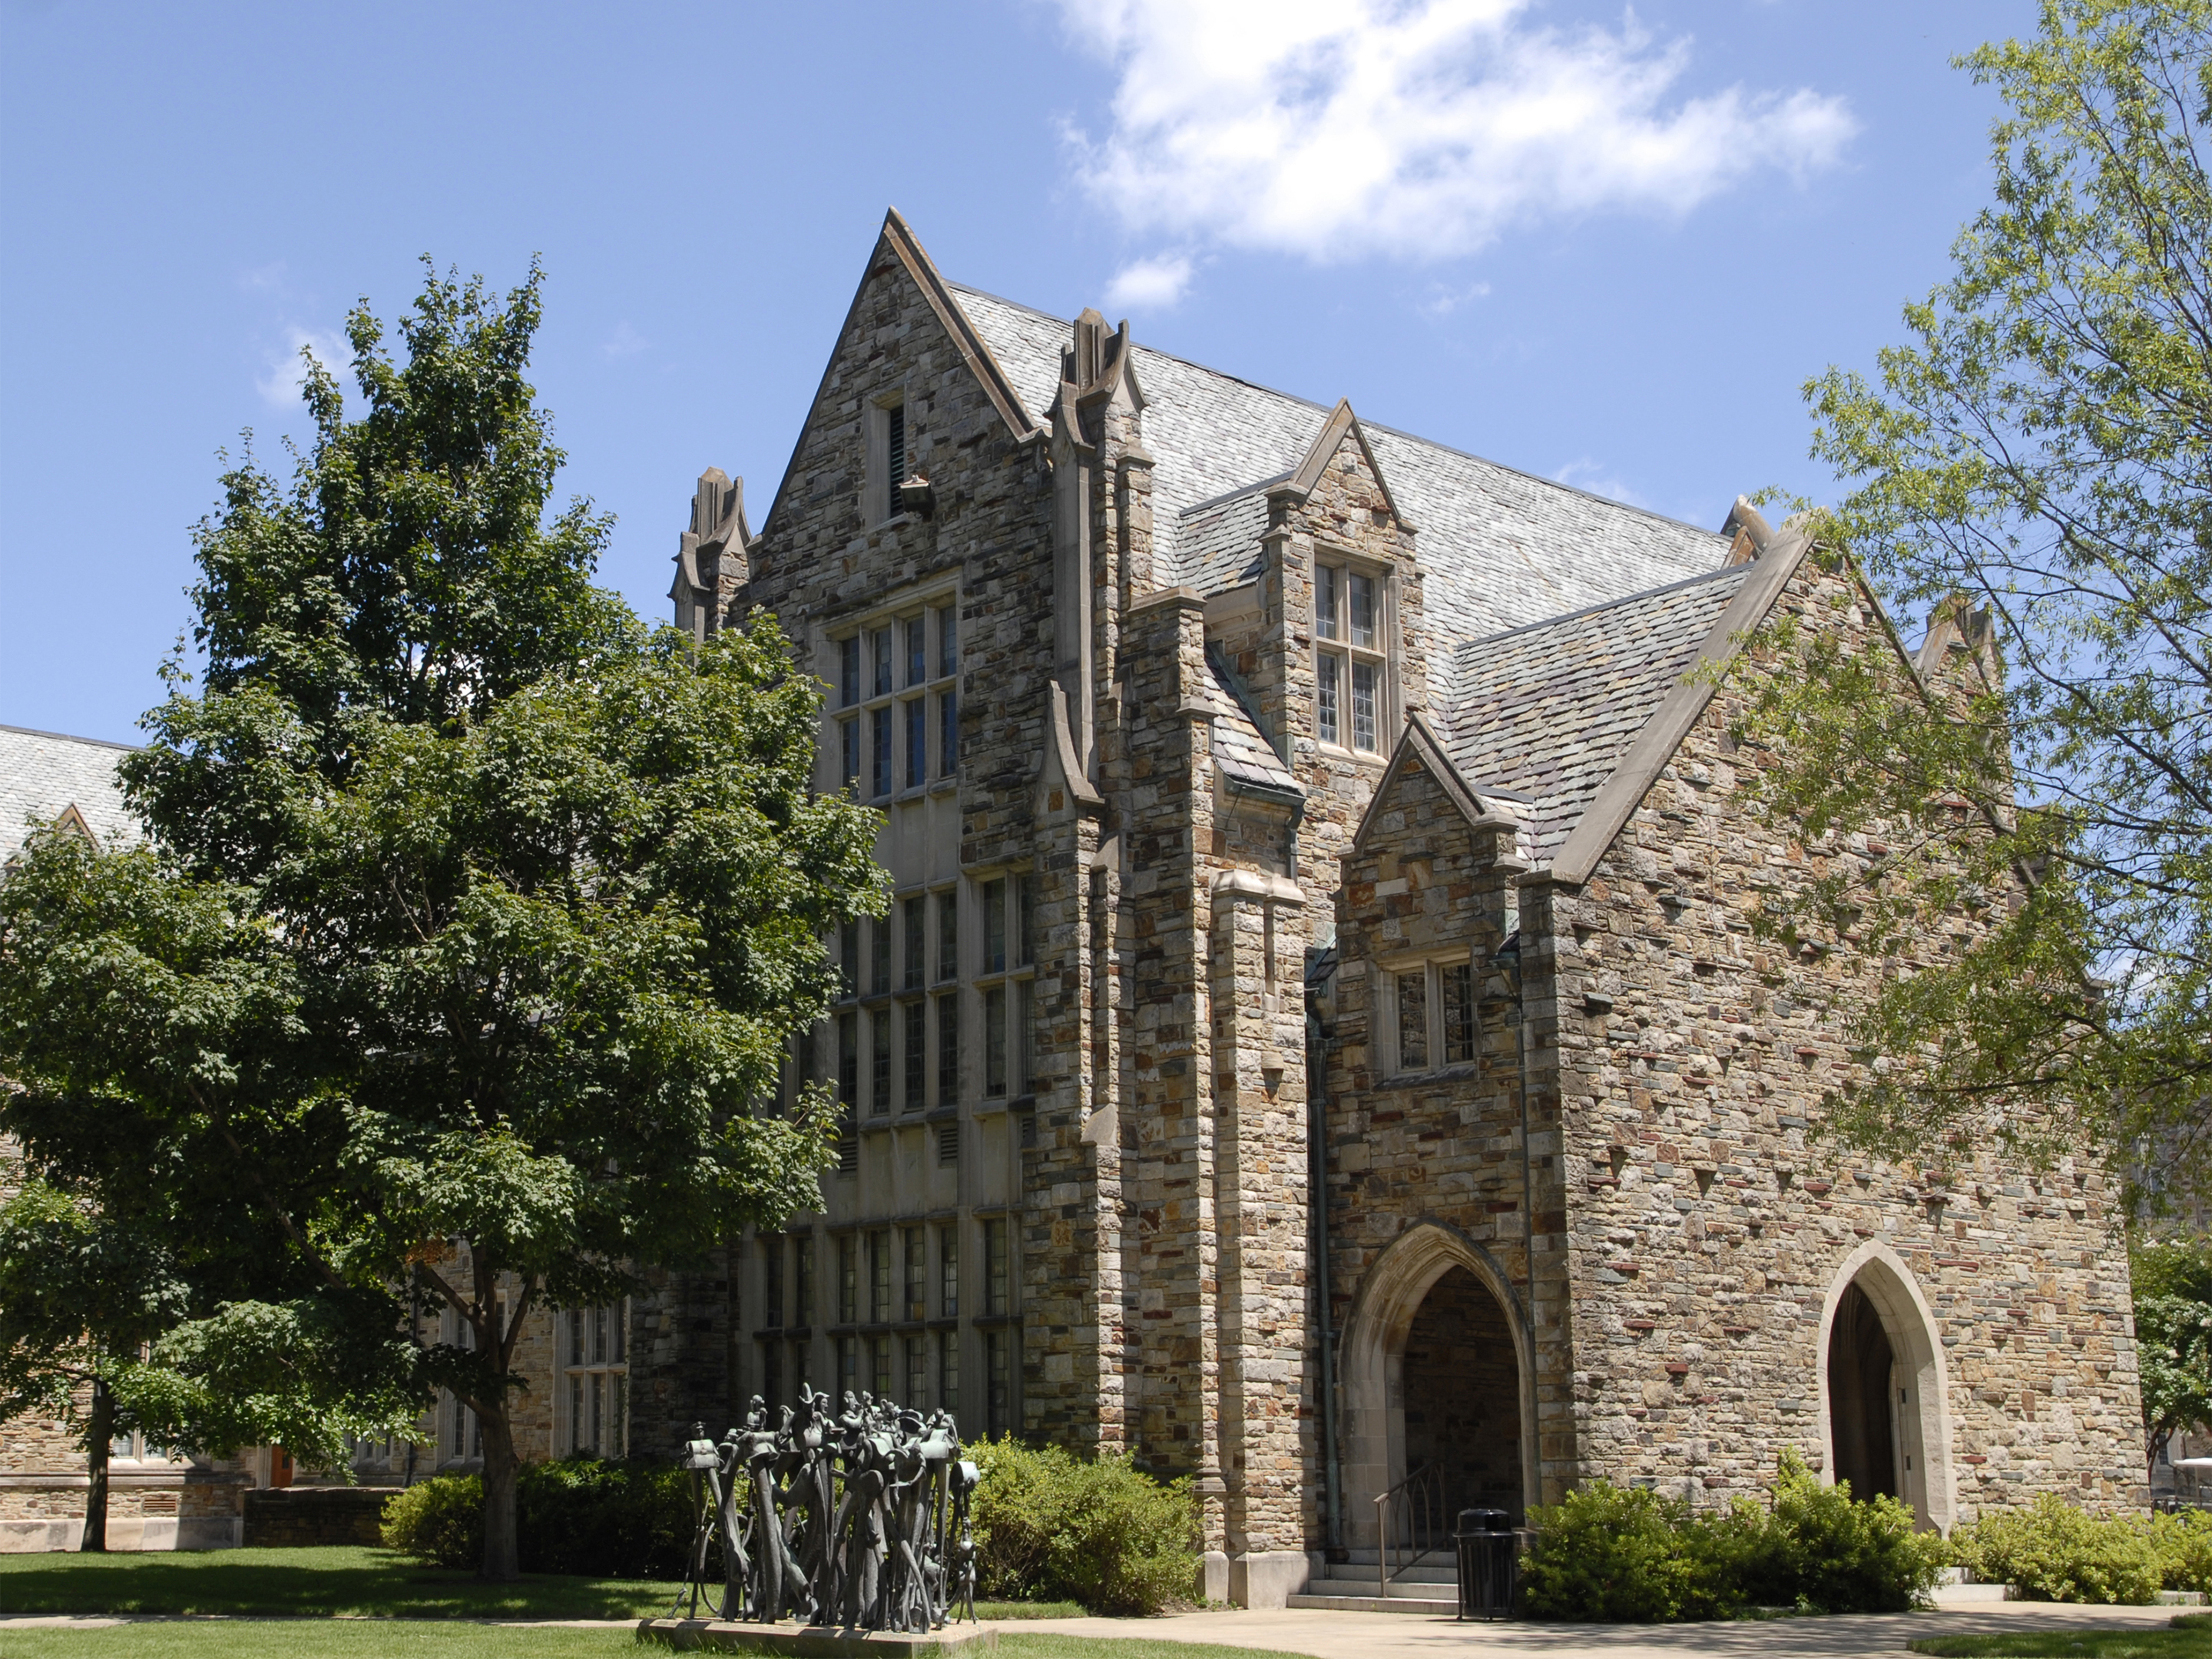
[382,1458,720,1579]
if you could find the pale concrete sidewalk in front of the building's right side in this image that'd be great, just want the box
[998,1601,2187,1659]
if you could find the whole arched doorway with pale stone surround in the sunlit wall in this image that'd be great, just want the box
[1816,1239,1955,1533]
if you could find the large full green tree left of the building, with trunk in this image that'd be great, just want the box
[0,253,885,1575]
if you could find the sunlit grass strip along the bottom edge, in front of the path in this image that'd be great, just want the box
[7,1619,1305,1659]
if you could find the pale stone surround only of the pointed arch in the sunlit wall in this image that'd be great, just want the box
[1814,1239,1958,1535]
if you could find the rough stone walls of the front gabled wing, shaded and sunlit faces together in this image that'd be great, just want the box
[1330,548,2144,1548]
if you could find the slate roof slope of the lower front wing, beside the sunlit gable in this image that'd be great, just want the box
[1435,564,1752,863]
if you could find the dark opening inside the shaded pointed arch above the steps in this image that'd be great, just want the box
[1400,1267,1522,1526]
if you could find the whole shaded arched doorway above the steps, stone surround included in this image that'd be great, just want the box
[1338,1221,1538,1548]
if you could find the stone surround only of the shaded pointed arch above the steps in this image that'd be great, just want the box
[1336,1219,1541,1548]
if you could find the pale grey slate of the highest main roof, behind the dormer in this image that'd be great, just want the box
[949,283,1727,644]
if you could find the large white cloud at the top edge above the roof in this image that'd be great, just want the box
[1060,0,1856,270]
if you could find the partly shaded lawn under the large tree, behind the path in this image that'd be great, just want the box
[0,1546,1081,1628]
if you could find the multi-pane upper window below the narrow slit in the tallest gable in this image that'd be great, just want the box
[832,601,960,801]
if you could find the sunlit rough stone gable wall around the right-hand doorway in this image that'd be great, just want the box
[1553,562,2144,1520]
